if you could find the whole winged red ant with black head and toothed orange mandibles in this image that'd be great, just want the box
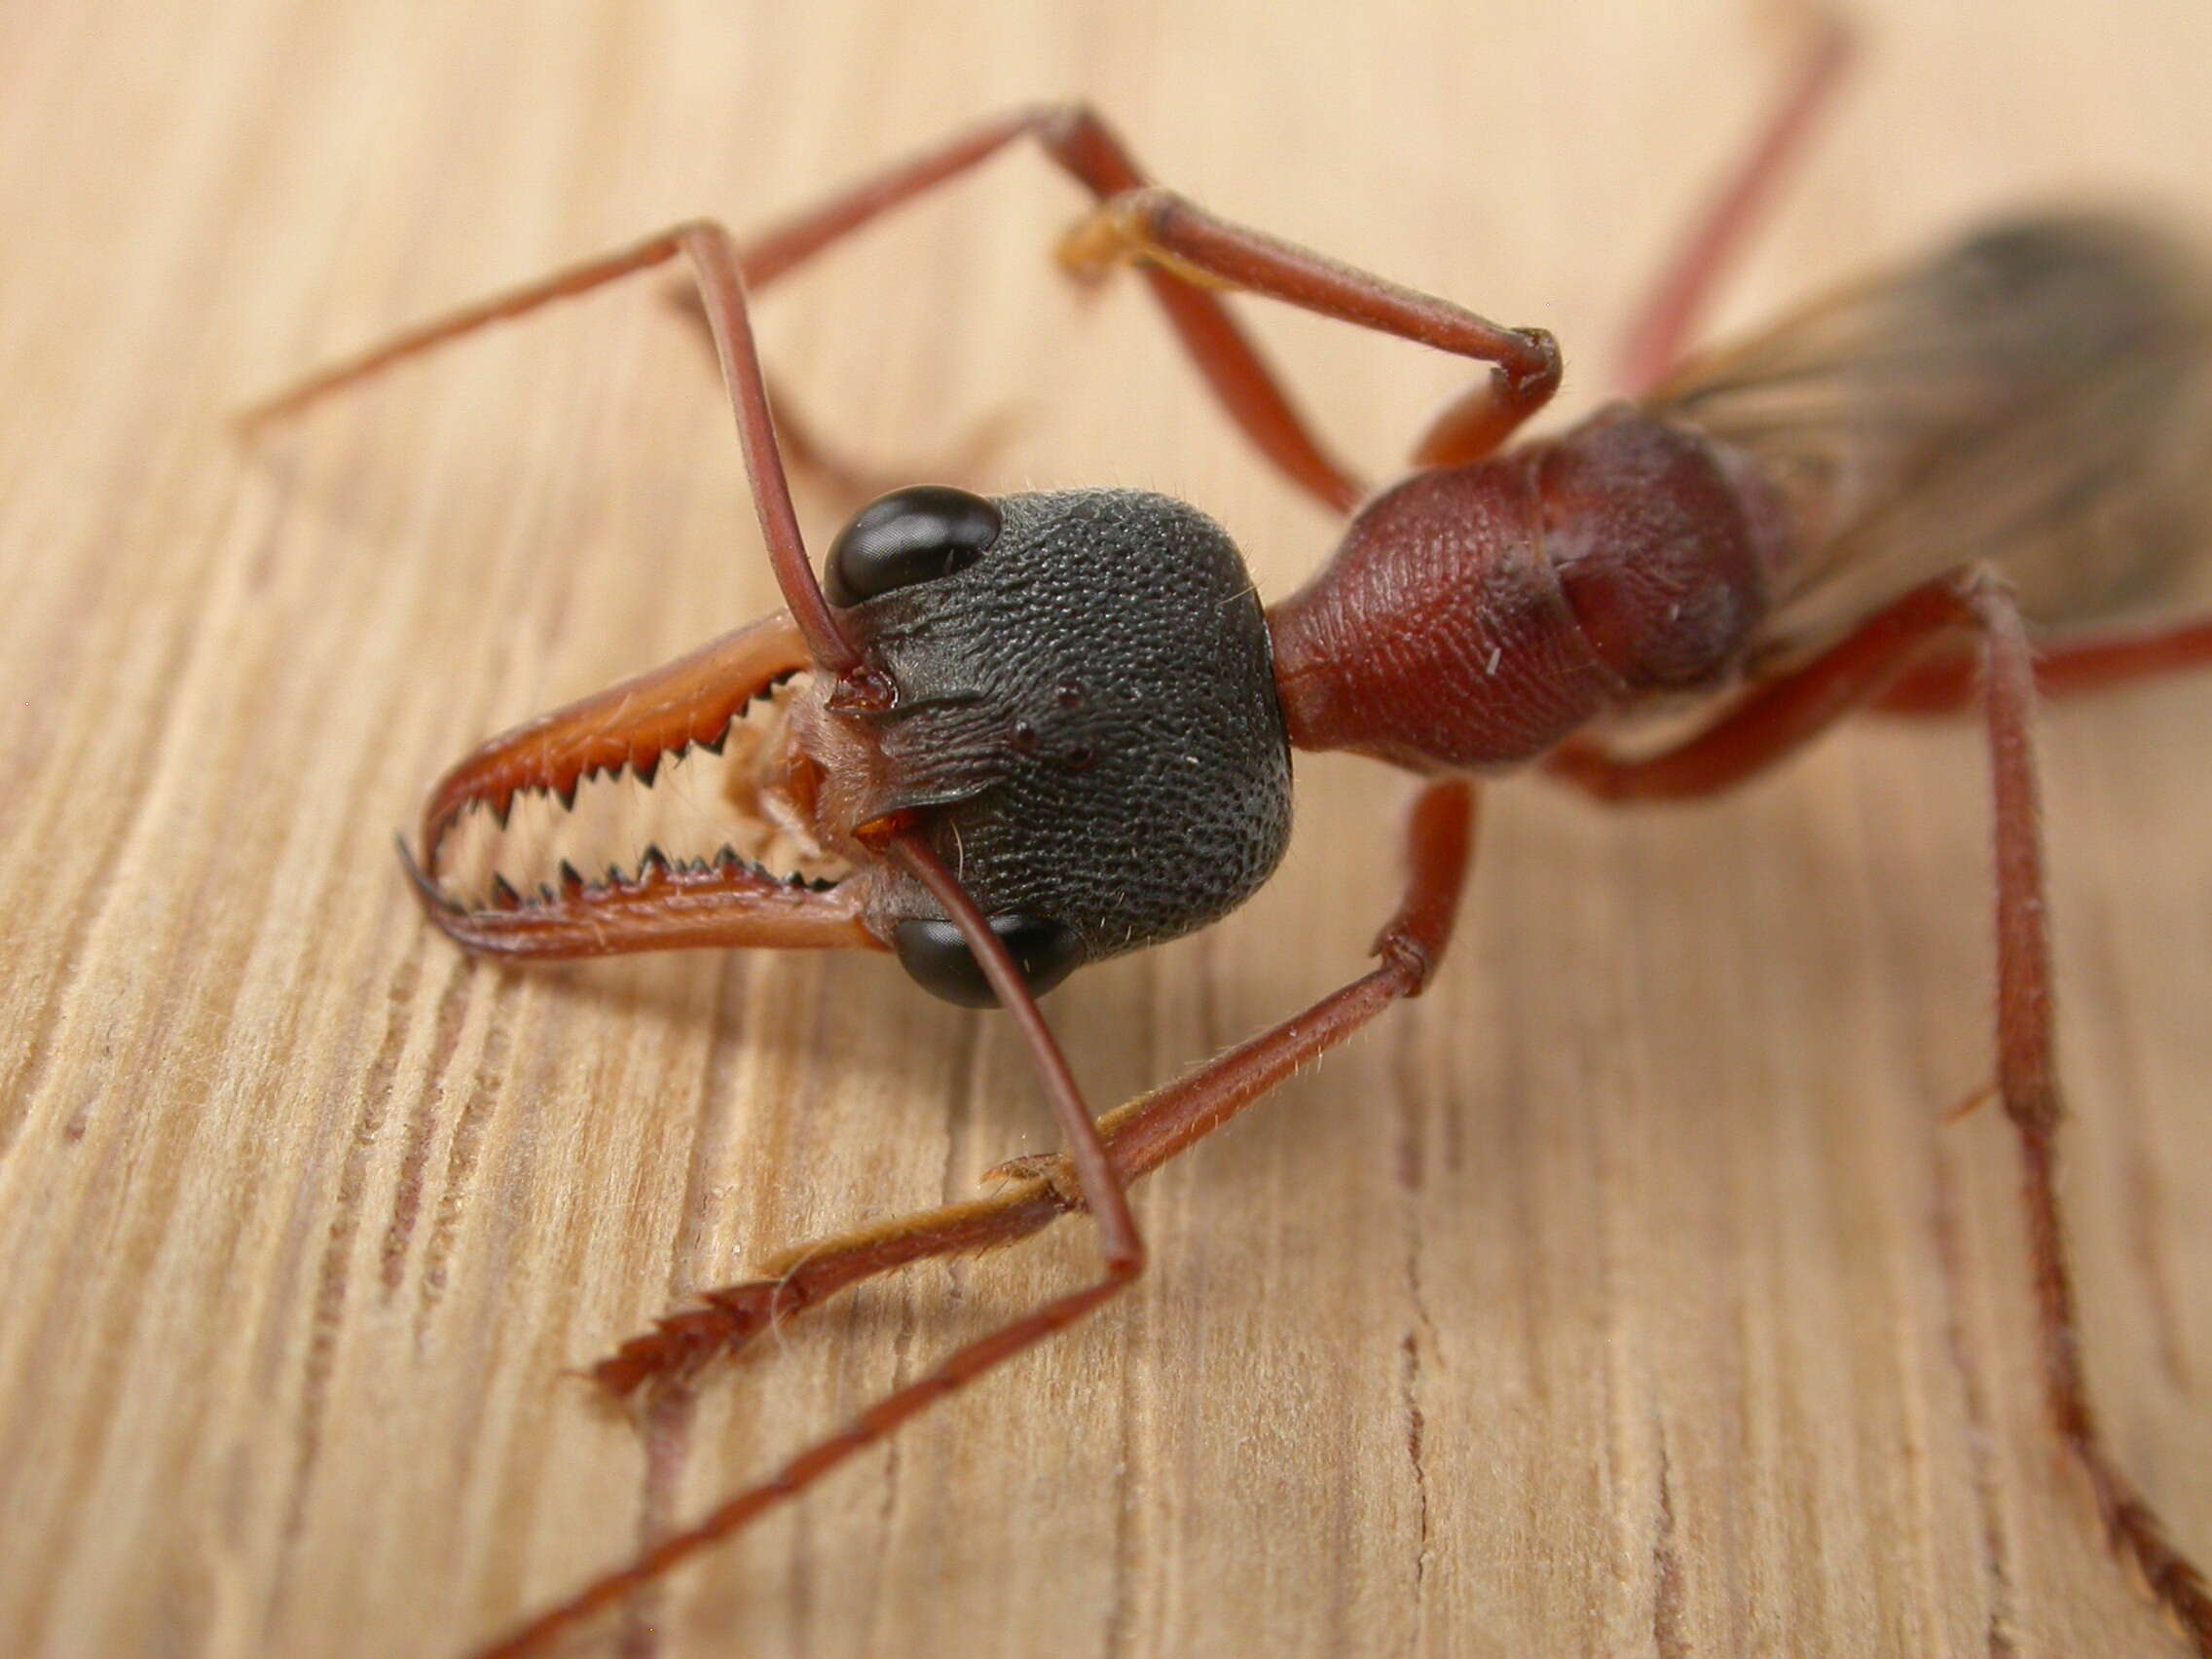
[245,19,2212,1657]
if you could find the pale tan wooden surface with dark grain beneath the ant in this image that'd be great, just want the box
[0,0,2212,1659]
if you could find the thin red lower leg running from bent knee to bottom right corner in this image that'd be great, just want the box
[1962,572,2212,1654]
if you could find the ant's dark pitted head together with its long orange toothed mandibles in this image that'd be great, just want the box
[409,487,1290,1004]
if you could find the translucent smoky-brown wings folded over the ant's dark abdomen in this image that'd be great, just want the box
[1650,214,2212,670]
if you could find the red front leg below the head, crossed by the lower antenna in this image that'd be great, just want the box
[591,781,1475,1396]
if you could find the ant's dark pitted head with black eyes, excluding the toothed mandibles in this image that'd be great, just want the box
[809,485,1290,1004]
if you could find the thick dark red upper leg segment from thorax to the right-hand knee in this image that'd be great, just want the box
[1544,577,1975,800]
